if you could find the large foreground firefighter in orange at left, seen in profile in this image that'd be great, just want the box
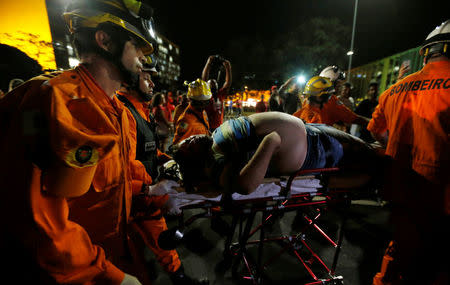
[0,0,153,285]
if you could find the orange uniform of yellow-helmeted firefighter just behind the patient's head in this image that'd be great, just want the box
[173,103,210,144]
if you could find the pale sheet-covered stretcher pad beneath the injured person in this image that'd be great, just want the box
[169,176,322,210]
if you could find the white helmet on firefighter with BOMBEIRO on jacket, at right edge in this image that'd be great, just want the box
[419,20,450,56]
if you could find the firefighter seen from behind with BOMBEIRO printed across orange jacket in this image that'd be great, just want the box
[367,20,450,284]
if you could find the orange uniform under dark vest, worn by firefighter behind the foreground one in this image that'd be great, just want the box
[117,91,181,272]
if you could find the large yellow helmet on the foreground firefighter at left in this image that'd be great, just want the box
[63,0,153,54]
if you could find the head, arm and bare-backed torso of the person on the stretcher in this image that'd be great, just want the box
[175,112,307,194]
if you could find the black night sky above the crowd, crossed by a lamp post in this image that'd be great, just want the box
[149,0,450,79]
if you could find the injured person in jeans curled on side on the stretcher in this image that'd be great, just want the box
[174,112,385,195]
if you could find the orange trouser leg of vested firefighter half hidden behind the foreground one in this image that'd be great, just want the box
[132,217,181,273]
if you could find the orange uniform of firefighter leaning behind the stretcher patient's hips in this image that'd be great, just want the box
[292,95,358,126]
